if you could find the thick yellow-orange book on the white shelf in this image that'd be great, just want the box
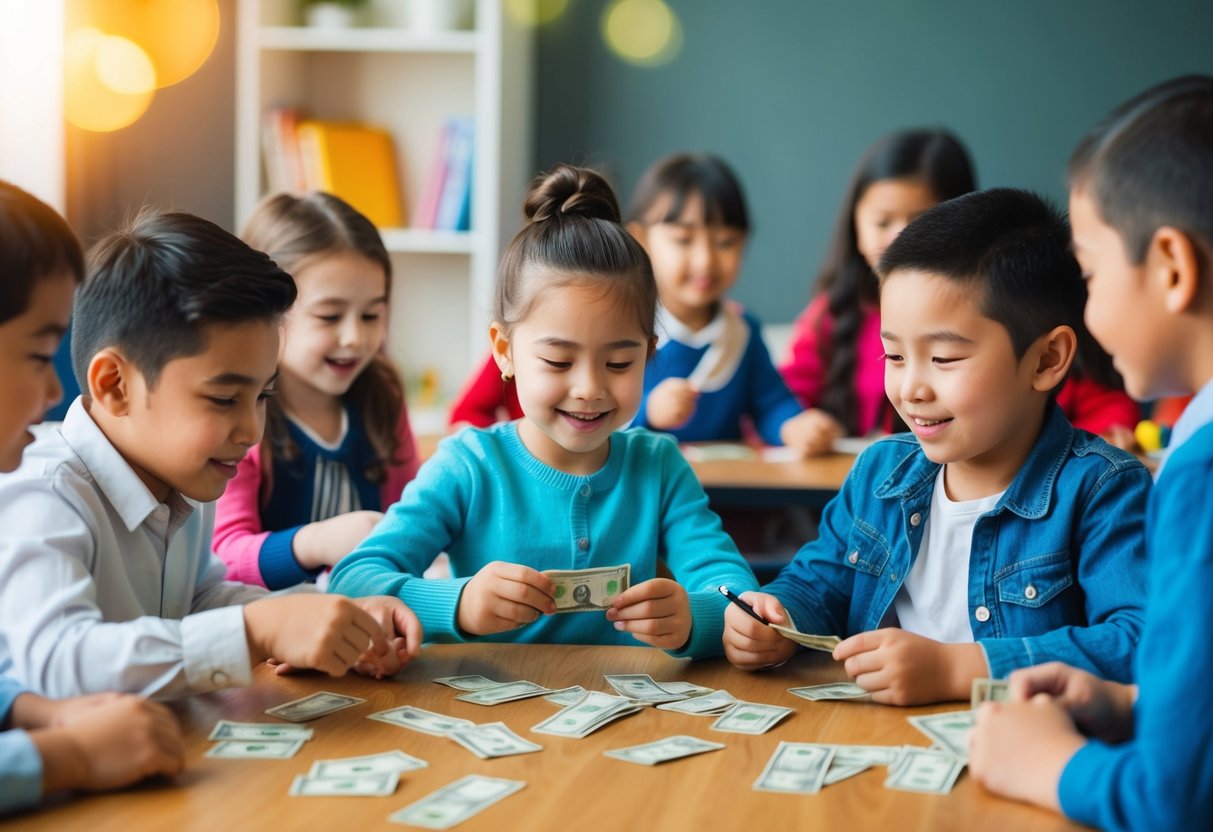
[297,119,404,228]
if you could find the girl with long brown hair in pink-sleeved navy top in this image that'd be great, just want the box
[215,193,418,589]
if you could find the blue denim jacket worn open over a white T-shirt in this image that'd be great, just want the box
[763,405,1151,682]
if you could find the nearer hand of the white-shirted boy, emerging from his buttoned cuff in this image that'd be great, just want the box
[244,594,388,676]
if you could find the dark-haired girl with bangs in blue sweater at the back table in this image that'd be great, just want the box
[627,154,824,450]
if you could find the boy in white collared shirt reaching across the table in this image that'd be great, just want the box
[0,207,421,697]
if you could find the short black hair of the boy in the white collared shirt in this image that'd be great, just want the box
[72,210,295,391]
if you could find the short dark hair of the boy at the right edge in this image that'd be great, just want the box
[1067,75,1213,263]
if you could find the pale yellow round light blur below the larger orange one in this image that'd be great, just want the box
[63,27,155,132]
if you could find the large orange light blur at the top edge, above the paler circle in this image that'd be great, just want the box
[68,0,220,87]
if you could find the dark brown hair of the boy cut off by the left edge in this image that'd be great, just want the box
[0,181,84,324]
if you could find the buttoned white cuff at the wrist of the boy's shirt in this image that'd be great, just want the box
[181,606,252,694]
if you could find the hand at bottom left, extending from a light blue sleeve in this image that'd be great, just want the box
[29,694,186,793]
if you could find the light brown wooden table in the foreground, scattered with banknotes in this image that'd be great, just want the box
[4,644,1078,832]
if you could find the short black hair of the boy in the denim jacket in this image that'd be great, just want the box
[877,188,1086,358]
